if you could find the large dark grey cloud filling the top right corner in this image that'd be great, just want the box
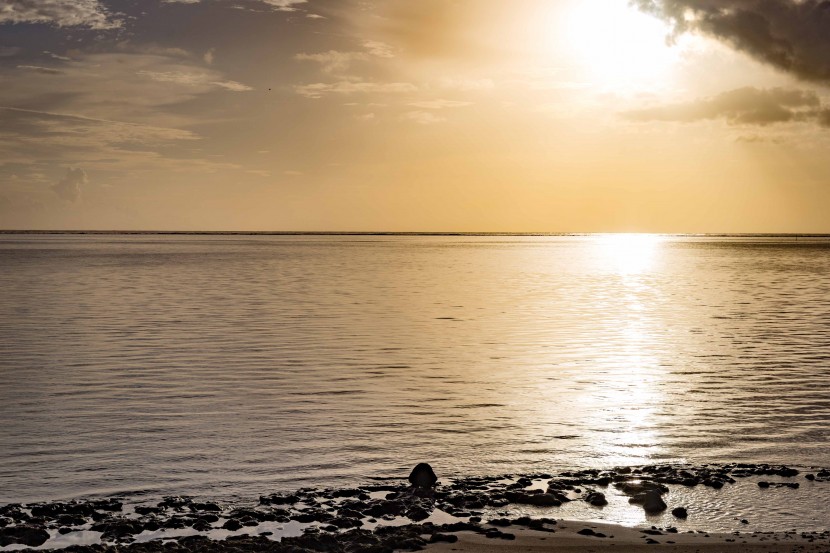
[632,0,830,82]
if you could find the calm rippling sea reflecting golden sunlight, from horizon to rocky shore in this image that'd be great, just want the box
[0,235,830,520]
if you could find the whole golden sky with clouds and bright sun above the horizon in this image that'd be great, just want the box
[0,0,830,233]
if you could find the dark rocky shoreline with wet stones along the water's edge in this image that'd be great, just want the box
[0,464,830,553]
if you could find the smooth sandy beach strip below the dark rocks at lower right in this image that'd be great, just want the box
[426,520,830,553]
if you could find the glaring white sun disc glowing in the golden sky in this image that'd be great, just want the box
[557,0,681,89]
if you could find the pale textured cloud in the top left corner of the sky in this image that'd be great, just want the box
[0,0,122,29]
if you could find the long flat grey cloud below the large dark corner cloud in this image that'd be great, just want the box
[623,87,830,126]
